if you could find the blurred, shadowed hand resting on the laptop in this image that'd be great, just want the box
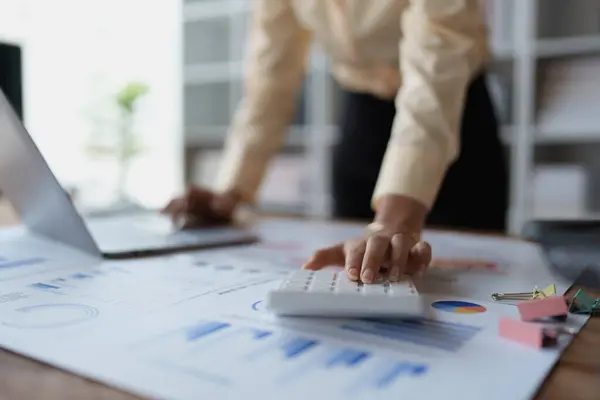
[161,187,241,228]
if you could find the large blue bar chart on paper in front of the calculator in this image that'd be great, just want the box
[136,321,429,396]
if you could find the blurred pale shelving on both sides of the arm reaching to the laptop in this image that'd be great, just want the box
[182,0,336,217]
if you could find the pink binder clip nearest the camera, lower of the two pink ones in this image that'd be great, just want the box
[498,317,573,349]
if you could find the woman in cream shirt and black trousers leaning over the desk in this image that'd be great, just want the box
[164,0,507,283]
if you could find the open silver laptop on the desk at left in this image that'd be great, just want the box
[0,90,258,258]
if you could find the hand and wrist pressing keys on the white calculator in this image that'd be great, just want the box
[304,195,432,283]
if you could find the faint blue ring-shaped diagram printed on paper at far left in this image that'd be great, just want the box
[2,304,99,329]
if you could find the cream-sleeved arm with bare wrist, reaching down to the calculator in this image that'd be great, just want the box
[373,0,486,230]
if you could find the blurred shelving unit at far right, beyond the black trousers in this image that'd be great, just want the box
[487,0,600,233]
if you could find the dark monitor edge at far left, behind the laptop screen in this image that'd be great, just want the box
[0,42,23,120]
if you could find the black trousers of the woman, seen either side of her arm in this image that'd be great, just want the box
[332,76,508,231]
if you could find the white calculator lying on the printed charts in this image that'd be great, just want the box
[265,270,427,318]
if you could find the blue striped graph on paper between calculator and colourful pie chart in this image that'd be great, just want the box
[340,320,481,352]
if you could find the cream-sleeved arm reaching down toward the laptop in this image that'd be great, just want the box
[217,0,310,203]
